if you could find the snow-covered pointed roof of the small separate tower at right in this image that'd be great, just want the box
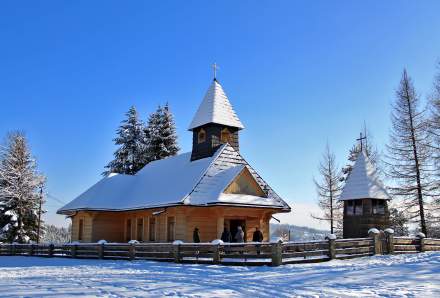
[339,152,391,201]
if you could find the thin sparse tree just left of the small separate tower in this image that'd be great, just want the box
[312,144,342,234]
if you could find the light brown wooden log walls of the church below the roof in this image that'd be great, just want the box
[72,206,277,242]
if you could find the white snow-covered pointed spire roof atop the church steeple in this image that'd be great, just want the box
[189,79,244,130]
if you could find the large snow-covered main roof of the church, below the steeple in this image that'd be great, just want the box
[58,144,290,214]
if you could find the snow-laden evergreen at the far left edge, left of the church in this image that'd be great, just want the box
[0,132,45,243]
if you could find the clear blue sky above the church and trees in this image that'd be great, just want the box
[0,1,440,225]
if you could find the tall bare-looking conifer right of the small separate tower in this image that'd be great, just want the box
[387,70,432,234]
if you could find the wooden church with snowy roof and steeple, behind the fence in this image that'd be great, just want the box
[58,79,290,242]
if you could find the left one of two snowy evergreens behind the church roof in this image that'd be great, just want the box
[103,106,146,176]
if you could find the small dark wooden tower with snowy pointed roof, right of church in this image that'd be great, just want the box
[339,151,391,238]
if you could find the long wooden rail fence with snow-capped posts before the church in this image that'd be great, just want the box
[0,233,440,266]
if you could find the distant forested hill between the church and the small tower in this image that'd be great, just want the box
[270,224,330,241]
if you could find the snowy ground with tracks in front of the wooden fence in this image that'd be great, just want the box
[0,253,440,297]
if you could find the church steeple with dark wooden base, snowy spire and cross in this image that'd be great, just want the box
[189,75,244,161]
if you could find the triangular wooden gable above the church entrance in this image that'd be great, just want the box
[223,167,267,197]
